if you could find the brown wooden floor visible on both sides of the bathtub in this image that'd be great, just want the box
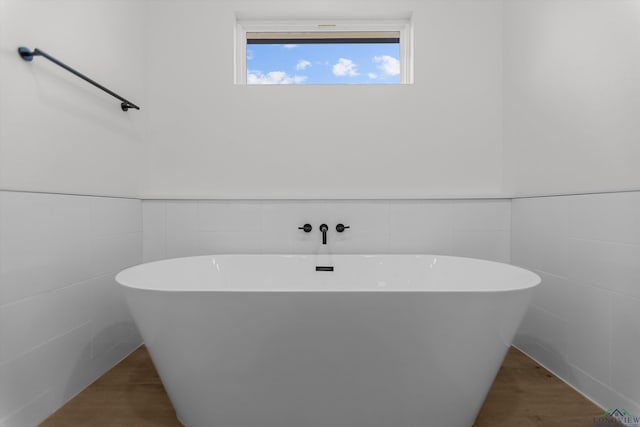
[41,347,603,427]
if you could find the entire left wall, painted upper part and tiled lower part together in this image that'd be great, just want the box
[0,0,146,427]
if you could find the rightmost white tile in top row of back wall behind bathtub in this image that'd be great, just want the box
[451,200,511,231]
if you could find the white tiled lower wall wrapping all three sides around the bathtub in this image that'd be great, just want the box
[12,192,640,427]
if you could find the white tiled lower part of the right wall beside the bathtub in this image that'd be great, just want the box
[511,192,640,414]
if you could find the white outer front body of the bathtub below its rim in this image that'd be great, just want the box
[126,288,530,427]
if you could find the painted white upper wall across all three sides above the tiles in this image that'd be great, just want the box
[6,0,640,198]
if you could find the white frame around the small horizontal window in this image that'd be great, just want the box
[234,19,413,85]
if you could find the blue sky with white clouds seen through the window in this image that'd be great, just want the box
[247,43,400,84]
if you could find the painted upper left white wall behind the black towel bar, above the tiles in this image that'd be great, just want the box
[0,0,146,196]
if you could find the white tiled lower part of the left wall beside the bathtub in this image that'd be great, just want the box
[0,191,142,427]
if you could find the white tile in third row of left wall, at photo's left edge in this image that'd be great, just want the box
[0,283,90,363]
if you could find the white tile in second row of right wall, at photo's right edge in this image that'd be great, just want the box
[567,238,640,297]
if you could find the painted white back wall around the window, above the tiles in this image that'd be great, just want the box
[142,0,502,199]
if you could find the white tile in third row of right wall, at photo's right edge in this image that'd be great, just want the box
[612,295,640,405]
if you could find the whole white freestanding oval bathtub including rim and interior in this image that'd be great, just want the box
[116,255,540,427]
